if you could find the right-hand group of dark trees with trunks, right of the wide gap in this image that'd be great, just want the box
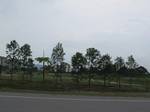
[72,48,148,88]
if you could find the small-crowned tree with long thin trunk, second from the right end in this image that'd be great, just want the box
[115,57,125,88]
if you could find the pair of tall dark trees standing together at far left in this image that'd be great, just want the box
[6,40,34,79]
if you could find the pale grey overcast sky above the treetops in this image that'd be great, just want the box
[0,0,150,70]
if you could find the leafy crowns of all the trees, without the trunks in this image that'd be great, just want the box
[6,40,146,76]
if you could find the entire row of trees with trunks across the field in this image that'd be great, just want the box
[6,40,148,87]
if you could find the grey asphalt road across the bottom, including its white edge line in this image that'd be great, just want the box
[0,93,150,112]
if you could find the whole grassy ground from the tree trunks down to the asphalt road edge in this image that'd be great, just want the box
[0,73,150,97]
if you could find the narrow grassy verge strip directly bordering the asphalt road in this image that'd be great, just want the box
[0,88,150,98]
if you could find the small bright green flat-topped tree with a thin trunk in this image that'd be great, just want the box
[35,56,49,81]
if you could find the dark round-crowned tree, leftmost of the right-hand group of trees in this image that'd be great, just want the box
[71,52,87,87]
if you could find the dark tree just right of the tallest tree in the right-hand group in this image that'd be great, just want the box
[98,54,114,87]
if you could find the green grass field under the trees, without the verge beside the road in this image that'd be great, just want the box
[0,73,150,92]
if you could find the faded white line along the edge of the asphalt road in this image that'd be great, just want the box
[0,95,150,103]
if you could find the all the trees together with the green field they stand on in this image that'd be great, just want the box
[0,40,150,92]
